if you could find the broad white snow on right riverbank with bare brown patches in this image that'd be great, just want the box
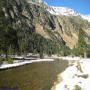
[55,59,90,90]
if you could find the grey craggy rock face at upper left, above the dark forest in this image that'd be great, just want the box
[2,0,55,30]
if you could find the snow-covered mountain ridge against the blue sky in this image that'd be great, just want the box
[47,6,90,22]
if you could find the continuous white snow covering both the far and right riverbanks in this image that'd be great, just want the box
[0,56,90,90]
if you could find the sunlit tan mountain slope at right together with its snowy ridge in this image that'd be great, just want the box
[46,5,90,48]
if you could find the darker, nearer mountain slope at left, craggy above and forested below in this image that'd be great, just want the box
[0,0,67,56]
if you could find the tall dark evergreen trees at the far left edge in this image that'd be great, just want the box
[0,0,18,62]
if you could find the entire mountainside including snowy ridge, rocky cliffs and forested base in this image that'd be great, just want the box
[0,0,90,56]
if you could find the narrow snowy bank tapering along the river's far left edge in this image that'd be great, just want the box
[0,59,54,69]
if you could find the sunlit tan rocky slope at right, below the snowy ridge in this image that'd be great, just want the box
[54,15,90,48]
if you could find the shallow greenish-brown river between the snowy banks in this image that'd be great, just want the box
[0,60,68,90]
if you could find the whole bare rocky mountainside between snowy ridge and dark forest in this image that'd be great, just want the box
[0,0,90,56]
